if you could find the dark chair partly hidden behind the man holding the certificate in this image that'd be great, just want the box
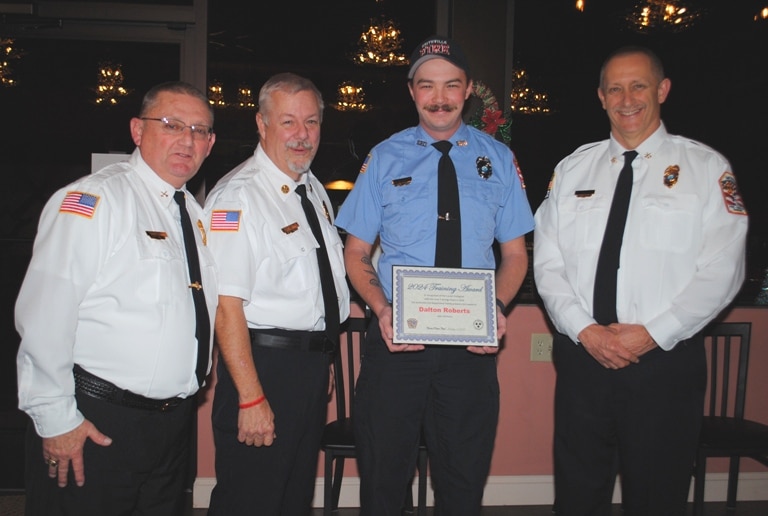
[320,317,427,516]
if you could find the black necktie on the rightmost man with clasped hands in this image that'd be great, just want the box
[592,151,637,324]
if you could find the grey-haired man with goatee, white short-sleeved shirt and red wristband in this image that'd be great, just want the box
[206,73,349,516]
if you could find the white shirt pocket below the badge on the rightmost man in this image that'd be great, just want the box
[640,194,697,253]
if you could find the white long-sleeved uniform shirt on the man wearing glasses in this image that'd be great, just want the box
[16,149,218,437]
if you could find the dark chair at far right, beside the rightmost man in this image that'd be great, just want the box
[693,323,768,516]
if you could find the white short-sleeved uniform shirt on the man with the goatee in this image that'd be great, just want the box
[205,145,349,331]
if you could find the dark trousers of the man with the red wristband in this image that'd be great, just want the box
[208,338,332,516]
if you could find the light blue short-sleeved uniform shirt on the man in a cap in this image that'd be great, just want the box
[336,124,533,301]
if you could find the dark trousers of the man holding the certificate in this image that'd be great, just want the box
[353,317,499,516]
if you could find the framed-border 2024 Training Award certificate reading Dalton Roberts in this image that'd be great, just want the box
[392,265,498,346]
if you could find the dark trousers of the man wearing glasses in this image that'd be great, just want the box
[25,393,196,516]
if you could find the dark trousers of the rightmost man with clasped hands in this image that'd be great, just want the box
[553,334,707,516]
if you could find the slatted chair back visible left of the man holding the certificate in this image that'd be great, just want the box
[333,317,368,421]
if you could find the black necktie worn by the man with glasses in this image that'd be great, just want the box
[173,191,211,387]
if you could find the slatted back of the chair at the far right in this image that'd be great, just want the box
[700,322,752,419]
